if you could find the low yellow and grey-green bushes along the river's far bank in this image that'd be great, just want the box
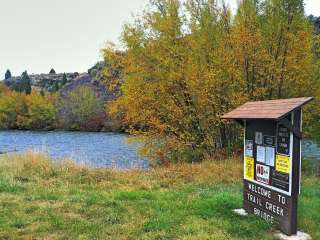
[0,84,123,132]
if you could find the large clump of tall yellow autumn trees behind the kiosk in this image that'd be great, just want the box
[103,0,316,161]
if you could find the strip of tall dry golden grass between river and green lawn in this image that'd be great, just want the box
[0,151,242,189]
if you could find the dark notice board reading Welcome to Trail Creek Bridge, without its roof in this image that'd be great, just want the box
[243,120,295,234]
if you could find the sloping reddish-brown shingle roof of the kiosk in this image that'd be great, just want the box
[221,97,313,119]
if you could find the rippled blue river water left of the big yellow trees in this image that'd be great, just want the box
[0,131,149,169]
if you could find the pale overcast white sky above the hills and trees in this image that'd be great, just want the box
[0,0,320,79]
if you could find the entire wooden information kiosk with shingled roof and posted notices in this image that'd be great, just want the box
[222,97,313,235]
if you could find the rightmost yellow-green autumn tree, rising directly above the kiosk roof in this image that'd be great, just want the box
[232,0,320,133]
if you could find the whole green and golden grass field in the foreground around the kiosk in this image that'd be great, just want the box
[0,152,320,240]
